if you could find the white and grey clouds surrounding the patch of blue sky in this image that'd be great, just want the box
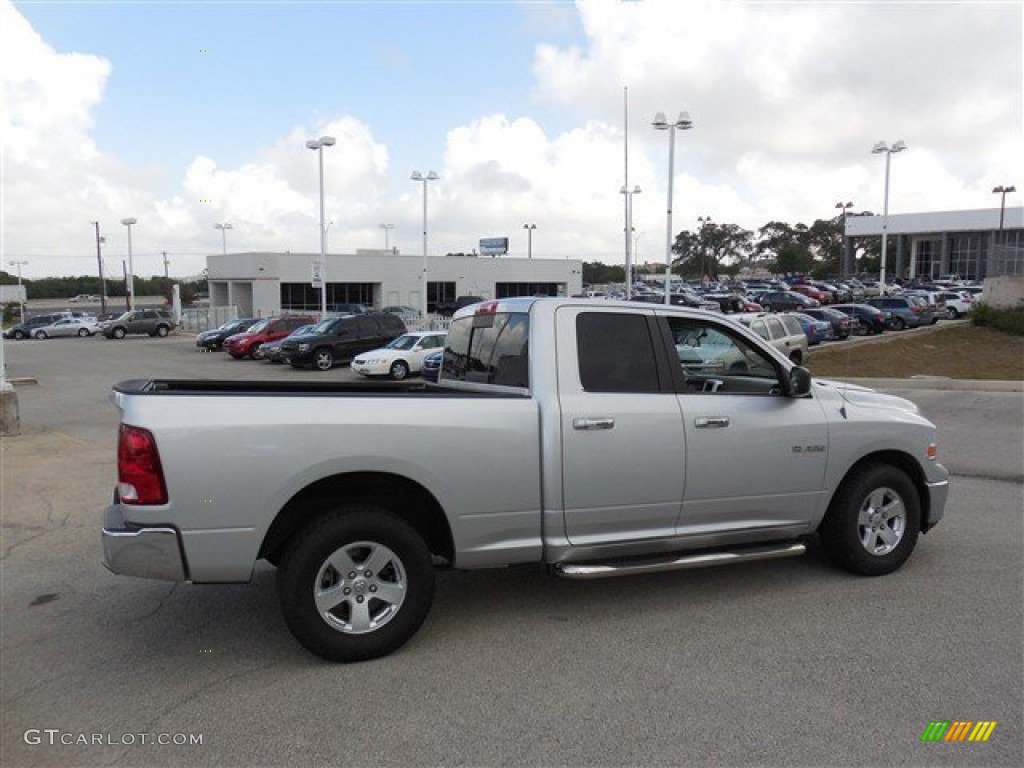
[0,0,1024,273]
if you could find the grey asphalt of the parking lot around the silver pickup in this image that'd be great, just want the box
[0,335,1024,767]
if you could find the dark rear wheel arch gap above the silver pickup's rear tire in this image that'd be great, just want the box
[258,472,455,563]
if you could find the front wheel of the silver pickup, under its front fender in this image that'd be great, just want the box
[818,464,921,577]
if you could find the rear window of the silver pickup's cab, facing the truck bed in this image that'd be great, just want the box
[441,312,529,387]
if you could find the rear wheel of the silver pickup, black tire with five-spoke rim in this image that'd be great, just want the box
[278,504,434,662]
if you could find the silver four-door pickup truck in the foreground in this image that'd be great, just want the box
[102,299,948,662]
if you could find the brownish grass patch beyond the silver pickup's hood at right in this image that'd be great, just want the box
[807,324,1024,381]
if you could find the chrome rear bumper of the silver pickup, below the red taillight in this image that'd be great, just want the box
[102,506,188,582]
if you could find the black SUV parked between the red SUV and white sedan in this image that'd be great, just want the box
[281,312,406,371]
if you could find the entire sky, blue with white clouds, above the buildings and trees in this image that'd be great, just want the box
[0,0,1024,276]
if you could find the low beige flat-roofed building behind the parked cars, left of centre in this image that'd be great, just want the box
[207,249,583,316]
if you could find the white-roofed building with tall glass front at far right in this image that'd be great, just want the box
[843,208,1024,281]
